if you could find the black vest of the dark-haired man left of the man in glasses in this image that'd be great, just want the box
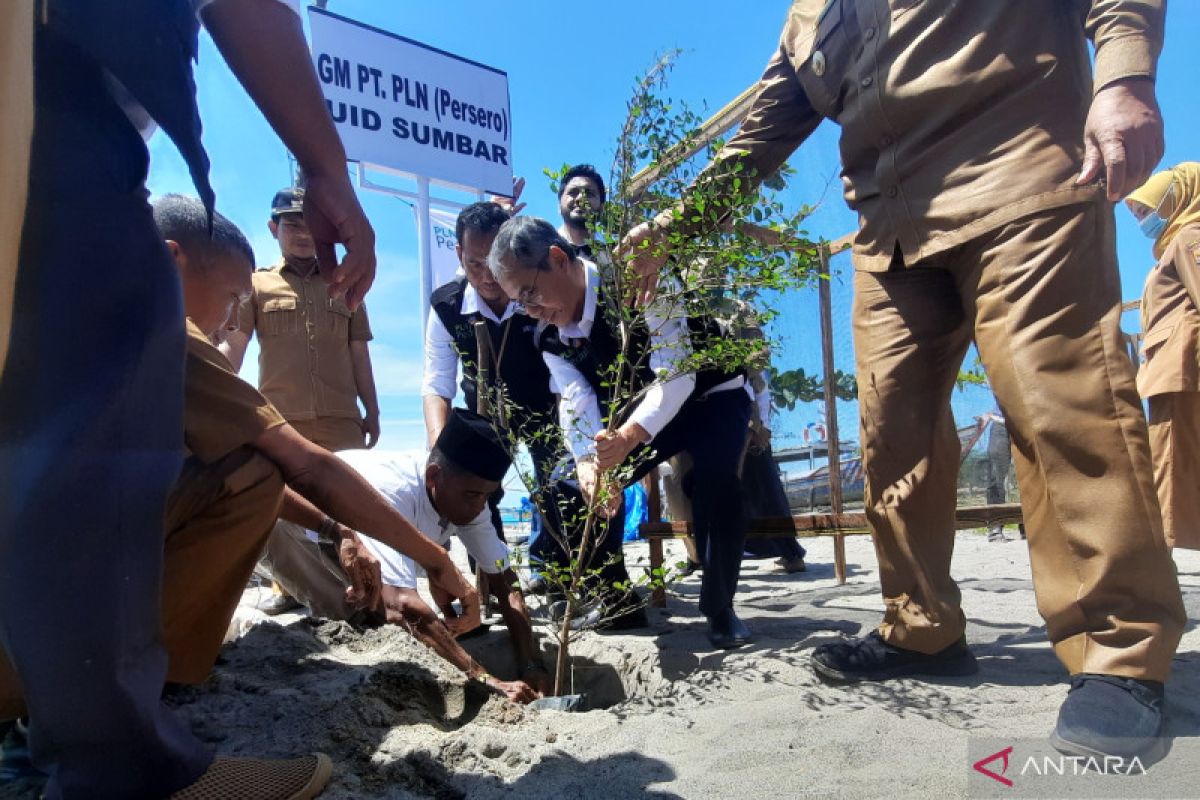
[430,277,554,432]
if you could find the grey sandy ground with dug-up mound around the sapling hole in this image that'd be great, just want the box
[2,531,1200,799]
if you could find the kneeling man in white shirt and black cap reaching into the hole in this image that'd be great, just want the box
[271,417,551,703]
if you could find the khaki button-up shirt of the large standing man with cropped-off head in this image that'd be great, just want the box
[686,0,1165,271]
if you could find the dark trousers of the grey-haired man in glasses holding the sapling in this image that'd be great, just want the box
[530,389,750,616]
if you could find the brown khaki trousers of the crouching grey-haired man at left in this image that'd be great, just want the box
[0,447,283,720]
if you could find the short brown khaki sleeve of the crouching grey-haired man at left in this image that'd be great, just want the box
[184,324,284,464]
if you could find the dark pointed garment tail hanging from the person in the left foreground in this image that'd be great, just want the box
[47,0,215,211]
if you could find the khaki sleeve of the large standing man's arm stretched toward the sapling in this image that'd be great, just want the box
[656,35,821,233]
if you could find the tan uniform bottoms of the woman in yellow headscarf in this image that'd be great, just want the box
[1148,392,1200,549]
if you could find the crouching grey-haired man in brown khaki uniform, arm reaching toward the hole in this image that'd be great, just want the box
[154,196,479,684]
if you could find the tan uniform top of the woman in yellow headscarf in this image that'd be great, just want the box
[1138,224,1200,397]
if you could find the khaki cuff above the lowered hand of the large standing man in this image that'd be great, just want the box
[1085,0,1166,91]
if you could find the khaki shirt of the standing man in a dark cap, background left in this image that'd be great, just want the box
[239,261,372,421]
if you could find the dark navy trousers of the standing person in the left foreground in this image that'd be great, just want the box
[0,29,211,799]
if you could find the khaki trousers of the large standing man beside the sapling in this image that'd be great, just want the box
[854,204,1186,680]
